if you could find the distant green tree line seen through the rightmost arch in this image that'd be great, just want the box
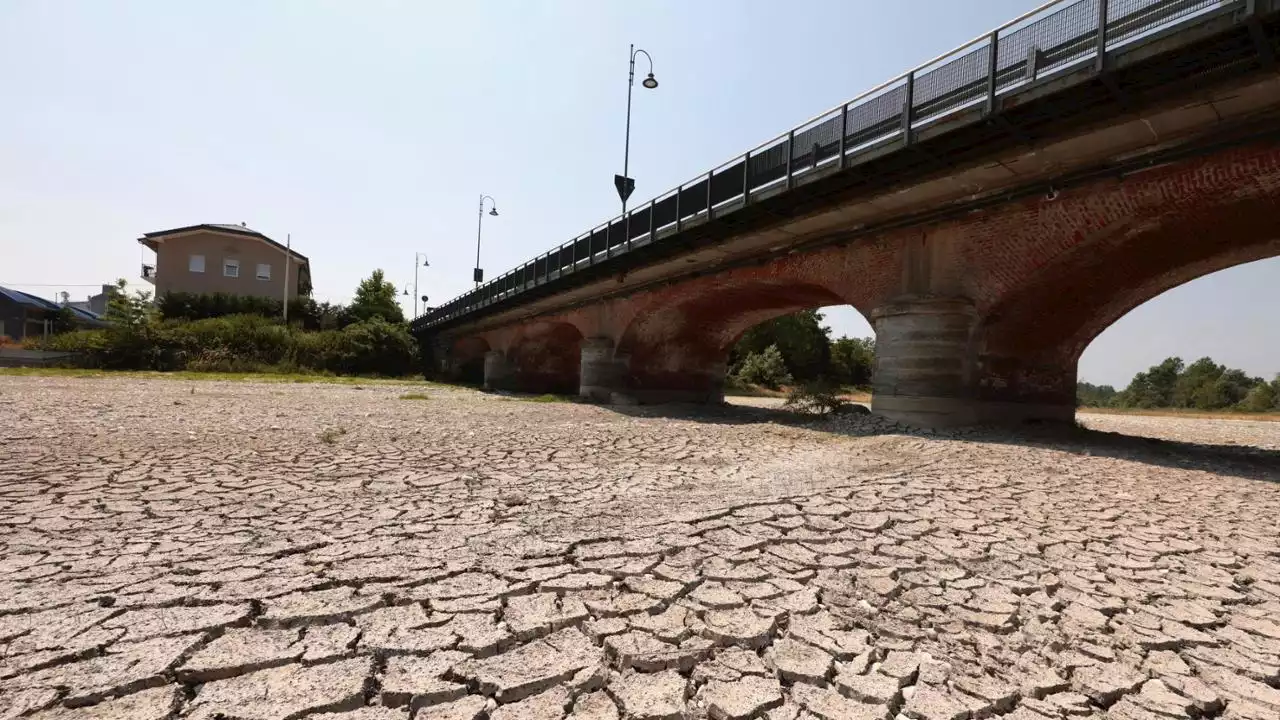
[1076,357,1280,413]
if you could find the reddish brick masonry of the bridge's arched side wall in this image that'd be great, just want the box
[444,143,1280,417]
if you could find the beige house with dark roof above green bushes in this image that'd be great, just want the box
[138,224,311,300]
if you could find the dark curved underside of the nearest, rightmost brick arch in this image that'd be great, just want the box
[974,190,1280,402]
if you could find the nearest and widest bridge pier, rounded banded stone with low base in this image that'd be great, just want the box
[872,297,1075,428]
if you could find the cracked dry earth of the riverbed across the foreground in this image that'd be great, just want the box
[0,377,1280,720]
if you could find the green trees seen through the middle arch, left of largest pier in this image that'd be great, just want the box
[728,310,876,389]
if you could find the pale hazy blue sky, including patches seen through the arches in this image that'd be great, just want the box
[0,0,1280,384]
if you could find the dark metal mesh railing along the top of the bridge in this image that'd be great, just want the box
[415,0,1252,327]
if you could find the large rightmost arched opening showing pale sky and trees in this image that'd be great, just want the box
[1076,258,1280,413]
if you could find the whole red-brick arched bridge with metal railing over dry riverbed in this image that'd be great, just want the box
[412,0,1280,425]
